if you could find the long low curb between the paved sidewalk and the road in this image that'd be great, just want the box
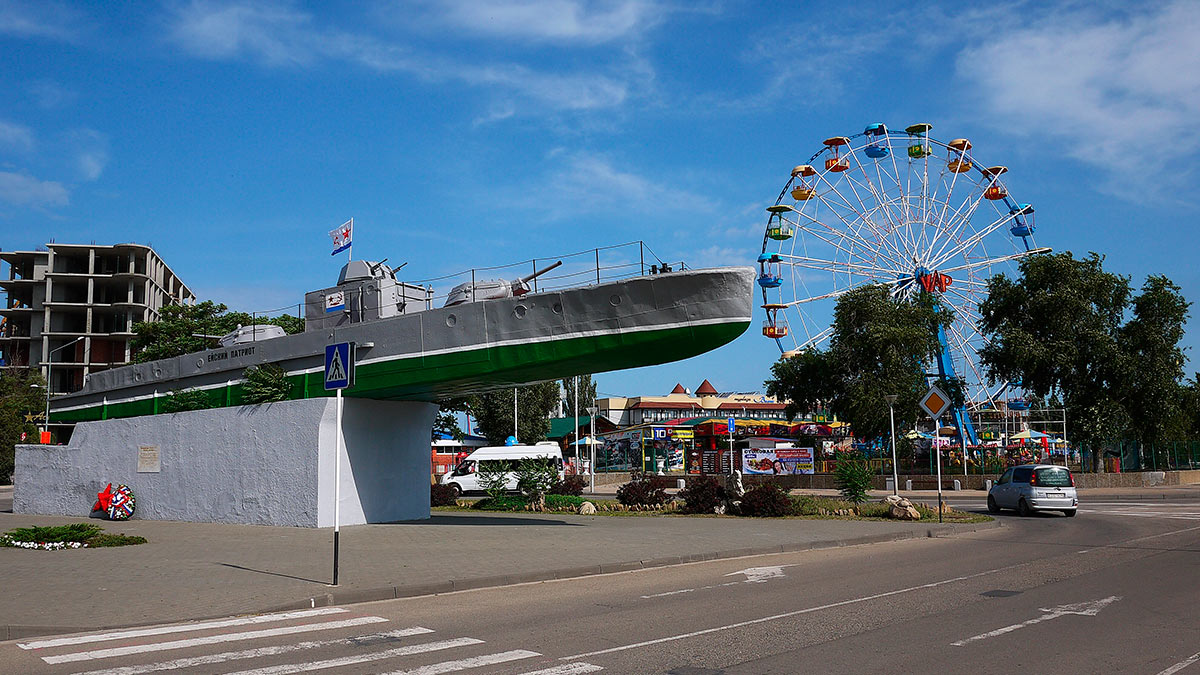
[0,520,1003,641]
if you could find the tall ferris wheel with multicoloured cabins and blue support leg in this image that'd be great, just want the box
[758,124,1050,443]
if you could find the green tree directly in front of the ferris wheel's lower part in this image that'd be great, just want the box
[766,286,962,438]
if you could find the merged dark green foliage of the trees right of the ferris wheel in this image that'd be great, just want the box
[979,252,1195,458]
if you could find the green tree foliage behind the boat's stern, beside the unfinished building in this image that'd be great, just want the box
[132,300,304,363]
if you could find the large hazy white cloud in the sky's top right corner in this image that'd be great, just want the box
[956,1,1200,174]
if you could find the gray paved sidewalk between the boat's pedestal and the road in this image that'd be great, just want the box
[0,488,997,640]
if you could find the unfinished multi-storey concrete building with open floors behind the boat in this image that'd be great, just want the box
[0,244,196,394]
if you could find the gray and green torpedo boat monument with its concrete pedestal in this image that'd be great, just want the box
[13,248,755,527]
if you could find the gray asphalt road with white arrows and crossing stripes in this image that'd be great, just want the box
[0,500,1200,675]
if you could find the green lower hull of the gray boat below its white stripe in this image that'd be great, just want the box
[50,322,750,423]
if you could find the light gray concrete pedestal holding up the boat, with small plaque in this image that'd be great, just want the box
[13,399,437,527]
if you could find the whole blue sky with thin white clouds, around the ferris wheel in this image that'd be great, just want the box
[0,0,1200,395]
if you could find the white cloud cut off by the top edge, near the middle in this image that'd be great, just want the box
[415,0,668,47]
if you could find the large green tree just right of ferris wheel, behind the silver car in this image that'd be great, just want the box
[979,252,1130,468]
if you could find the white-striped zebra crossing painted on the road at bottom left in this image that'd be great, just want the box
[10,607,604,675]
